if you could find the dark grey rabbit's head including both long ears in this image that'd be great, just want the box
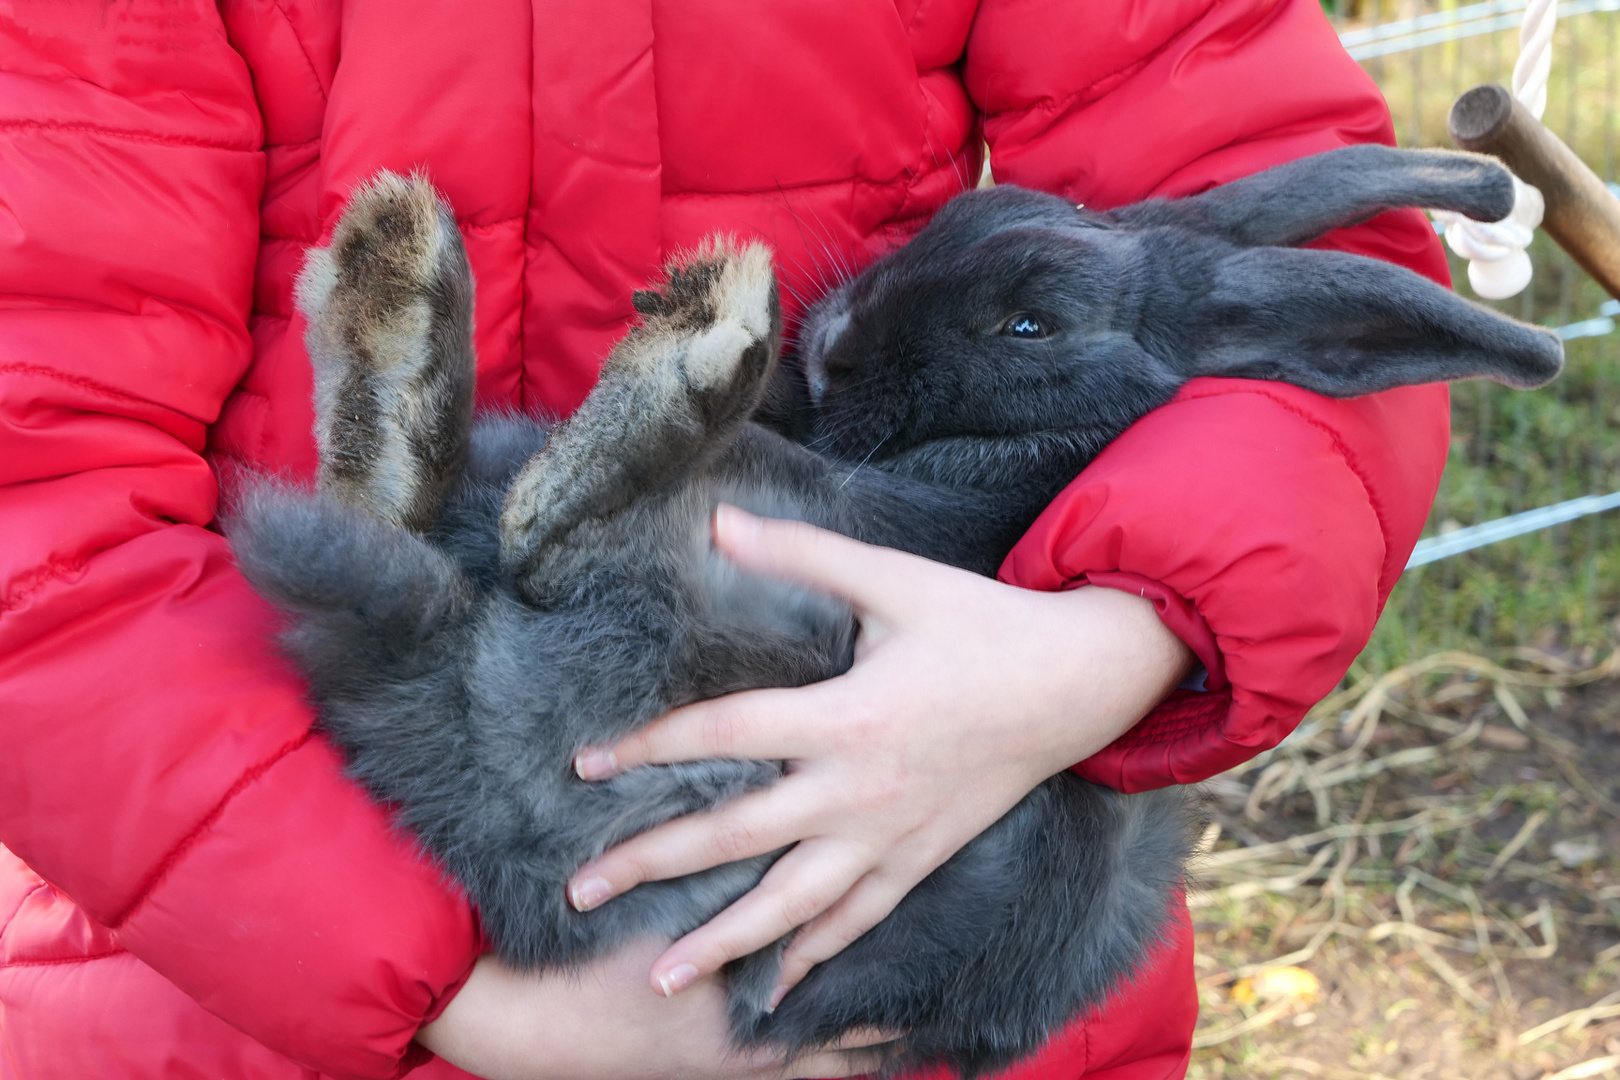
[797,146,1563,461]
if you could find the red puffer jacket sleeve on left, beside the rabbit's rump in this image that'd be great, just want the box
[0,0,480,1077]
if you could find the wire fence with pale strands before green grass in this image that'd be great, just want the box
[1324,0,1620,675]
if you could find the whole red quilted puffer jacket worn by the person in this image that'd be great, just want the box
[0,0,1447,1080]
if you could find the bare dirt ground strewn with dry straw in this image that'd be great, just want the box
[1191,653,1620,1080]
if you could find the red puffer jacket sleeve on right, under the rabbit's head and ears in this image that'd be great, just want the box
[966,0,1450,790]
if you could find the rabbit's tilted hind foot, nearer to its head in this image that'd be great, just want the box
[501,240,781,572]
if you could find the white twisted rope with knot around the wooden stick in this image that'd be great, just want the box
[1434,0,1558,300]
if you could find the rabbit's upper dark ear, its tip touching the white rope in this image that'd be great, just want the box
[1113,144,1513,246]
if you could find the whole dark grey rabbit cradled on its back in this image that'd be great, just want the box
[230,146,1563,1074]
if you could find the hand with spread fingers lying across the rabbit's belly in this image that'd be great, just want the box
[569,507,1192,1004]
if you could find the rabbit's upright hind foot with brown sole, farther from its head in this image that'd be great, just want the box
[296,170,475,529]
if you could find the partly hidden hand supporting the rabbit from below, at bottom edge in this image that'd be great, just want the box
[416,941,885,1080]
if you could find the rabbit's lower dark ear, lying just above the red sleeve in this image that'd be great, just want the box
[1178,248,1563,397]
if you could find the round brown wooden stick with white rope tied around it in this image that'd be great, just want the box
[1450,83,1620,298]
